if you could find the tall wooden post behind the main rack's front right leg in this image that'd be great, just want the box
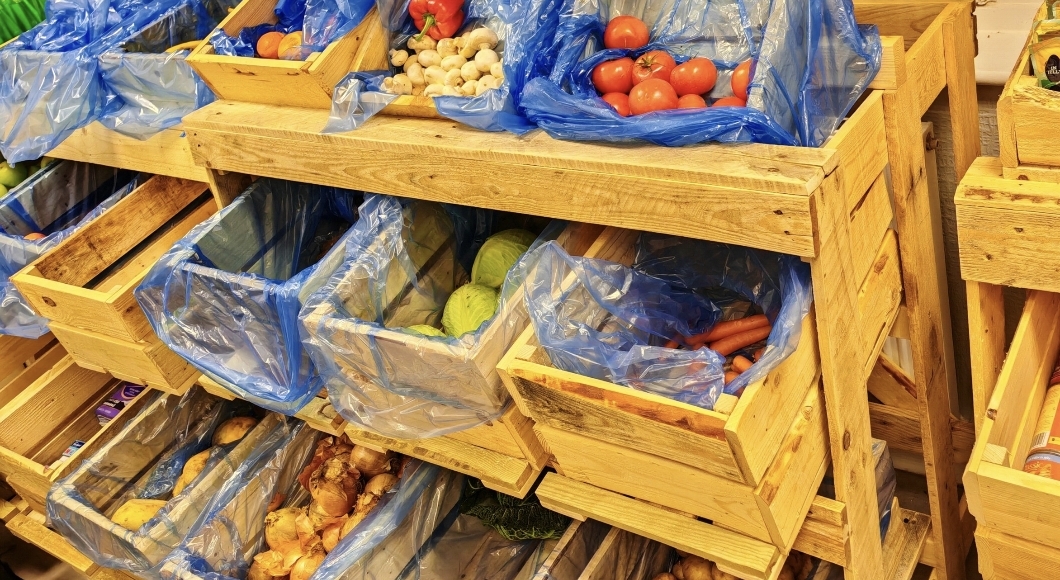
[883,67,965,580]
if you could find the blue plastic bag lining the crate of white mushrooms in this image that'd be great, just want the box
[323,0,563,135]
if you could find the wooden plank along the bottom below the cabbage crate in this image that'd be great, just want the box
[346,423,541,497]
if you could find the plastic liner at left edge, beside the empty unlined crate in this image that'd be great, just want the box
[0,161,137,338]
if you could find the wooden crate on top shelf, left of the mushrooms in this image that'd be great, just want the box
[188,0,387,110]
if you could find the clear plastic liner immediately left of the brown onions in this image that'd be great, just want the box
[159,421,321,580]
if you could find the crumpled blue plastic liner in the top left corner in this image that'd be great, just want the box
[0,0,192,162]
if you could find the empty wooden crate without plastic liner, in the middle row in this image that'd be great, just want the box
[12,176,216,393]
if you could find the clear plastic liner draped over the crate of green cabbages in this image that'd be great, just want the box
[299,196,563,438]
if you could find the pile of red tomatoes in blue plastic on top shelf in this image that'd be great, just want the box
[593,16,754,117]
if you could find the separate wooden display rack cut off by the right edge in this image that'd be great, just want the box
[954,6,1060,580]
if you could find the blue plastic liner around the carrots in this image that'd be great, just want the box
[525,233,812,409]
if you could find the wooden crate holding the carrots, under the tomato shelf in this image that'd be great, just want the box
[499,223,829,550]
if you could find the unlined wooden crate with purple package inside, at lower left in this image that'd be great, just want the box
[0,352,147,513]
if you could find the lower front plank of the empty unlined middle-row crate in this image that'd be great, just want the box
[51,321,200,394]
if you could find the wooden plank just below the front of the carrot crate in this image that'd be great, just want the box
[536,424,771,542]
